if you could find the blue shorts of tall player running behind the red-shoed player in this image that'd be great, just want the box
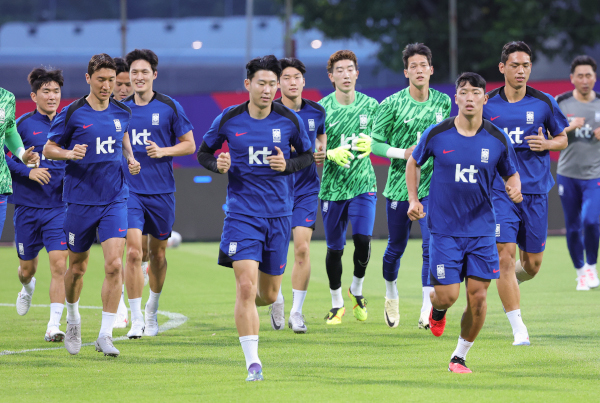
[492,190,548,253]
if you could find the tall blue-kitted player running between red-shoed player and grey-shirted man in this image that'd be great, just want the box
[483,42,569,346]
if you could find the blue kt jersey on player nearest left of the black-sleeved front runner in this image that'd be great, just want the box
[123,92,194,194]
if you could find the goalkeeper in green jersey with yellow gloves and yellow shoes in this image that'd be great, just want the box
[319,50,379,325]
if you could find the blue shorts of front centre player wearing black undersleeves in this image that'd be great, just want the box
[219,213,292,276]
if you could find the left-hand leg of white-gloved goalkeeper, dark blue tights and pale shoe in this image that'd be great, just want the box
[383,199,412,327]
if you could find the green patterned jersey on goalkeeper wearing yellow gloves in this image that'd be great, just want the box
[319,91,379,201]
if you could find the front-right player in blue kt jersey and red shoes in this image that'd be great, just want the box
[406,73,523,373]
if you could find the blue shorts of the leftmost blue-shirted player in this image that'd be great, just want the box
[13,206,67,260]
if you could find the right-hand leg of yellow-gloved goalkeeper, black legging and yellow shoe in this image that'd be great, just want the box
[348,192,377,321]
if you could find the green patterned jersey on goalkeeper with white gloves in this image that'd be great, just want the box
[372,87,451,201]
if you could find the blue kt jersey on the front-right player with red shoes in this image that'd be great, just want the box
[412,116,517,237]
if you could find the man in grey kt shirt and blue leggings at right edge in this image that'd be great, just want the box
[556,56,600,291]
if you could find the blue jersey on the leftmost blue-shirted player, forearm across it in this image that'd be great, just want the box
[6,110,65,208]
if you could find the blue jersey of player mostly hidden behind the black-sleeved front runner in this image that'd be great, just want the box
[275,98,325,197]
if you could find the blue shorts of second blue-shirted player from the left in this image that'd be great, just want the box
[64,200,128,253]
